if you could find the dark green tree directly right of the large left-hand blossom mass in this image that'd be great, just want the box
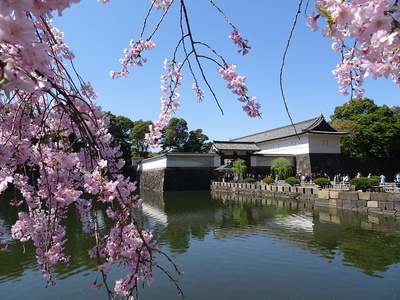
[107,112,134,166]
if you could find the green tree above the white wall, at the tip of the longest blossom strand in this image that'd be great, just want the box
[161,118,189,153]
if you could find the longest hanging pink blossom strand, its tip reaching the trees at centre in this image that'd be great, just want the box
[146,60,182,148]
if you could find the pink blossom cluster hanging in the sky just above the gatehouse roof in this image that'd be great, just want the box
[217,64,261,117]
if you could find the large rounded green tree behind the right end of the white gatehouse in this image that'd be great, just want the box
[331,98,400,158]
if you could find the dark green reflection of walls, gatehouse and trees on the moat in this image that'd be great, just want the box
[141,190,400,276]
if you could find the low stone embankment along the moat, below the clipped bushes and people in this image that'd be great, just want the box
[211,182,400,218]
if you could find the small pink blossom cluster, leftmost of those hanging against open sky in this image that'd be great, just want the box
[110,38,156,78]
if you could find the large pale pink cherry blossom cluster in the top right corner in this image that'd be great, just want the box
[307,0,400,97]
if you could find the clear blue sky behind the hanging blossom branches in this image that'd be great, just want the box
[54,0,399,144]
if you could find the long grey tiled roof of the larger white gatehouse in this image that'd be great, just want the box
[231,115,347,143]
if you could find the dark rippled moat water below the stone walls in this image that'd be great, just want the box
[0,191,400,300]
